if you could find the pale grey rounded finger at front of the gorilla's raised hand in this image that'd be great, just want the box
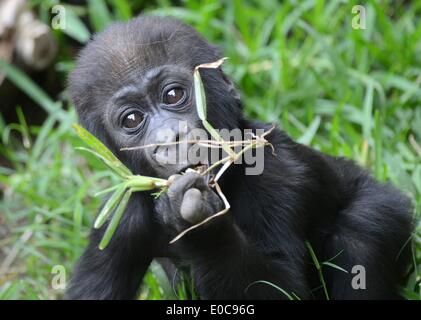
[180,188,206,224]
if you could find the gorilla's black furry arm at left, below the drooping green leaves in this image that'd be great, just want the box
[67,195,156,299]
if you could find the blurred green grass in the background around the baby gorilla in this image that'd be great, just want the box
[0,0,421,299]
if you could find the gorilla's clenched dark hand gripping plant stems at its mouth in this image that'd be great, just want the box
[156,172,223,235]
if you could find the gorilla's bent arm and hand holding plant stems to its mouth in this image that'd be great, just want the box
[156,173,309,299]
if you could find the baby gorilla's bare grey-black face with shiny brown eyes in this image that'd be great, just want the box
[102,65,206,178]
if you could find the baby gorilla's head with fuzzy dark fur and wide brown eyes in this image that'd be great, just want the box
[69,17,241,177]
